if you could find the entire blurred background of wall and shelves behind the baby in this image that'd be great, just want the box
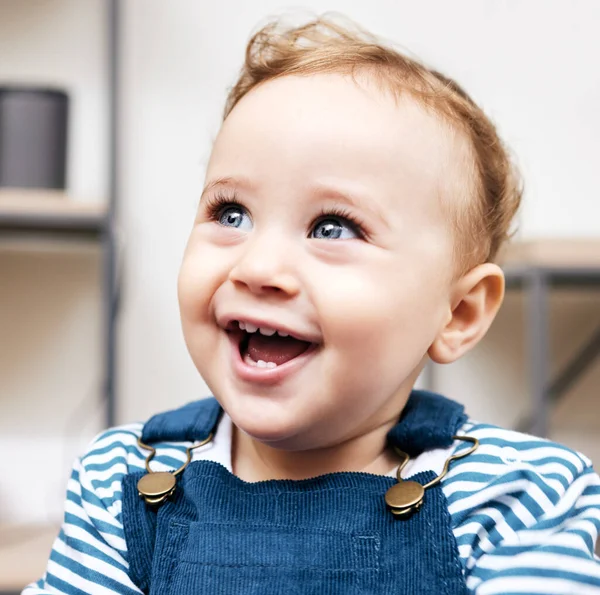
[0,0,600,592]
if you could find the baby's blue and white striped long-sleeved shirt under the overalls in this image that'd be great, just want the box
[22,414,600,595]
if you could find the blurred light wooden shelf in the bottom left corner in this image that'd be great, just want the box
[0,525,59,593]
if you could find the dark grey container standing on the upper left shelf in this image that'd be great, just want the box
[0,85,69,189]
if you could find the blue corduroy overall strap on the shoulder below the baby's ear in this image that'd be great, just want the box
[387,390,467,457]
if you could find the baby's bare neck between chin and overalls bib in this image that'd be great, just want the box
[232,422,398,482]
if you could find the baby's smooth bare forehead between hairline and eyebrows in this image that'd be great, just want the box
[207,74,458,224]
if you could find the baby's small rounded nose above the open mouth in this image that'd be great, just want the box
[229,234,300,297]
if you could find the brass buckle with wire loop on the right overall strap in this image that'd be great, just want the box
[385,436,479,518]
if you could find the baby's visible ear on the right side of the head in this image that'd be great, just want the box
[428,262,504,364]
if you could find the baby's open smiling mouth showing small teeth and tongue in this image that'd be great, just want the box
[232,321,315,369]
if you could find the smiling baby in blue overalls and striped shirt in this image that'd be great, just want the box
[24,14,600,595]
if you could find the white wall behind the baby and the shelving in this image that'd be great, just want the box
[0,0,600,522]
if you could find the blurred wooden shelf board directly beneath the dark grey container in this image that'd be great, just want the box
[0,188,107,235]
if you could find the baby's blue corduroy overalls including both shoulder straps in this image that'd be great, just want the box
[123,391,467,595]
